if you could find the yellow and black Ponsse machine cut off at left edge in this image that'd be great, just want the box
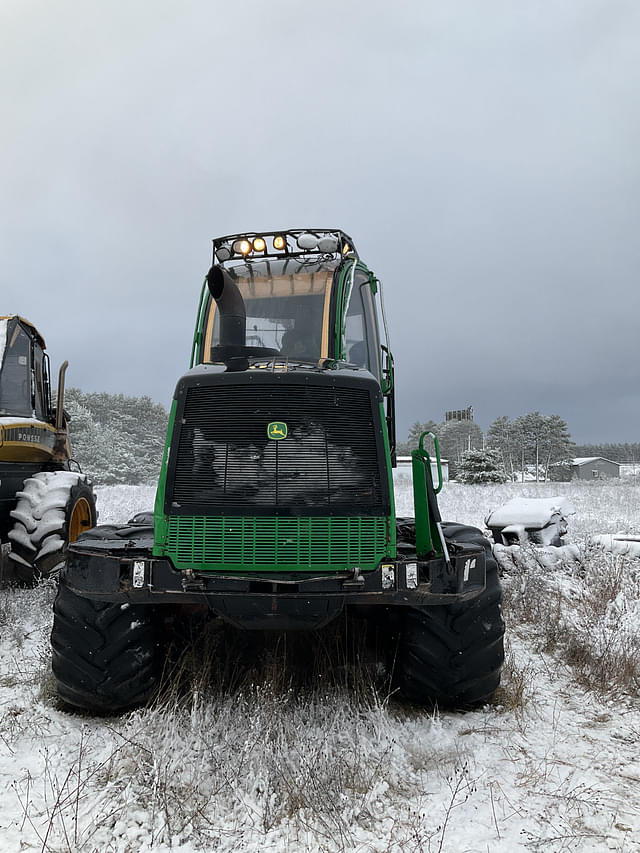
[0,315,96,583]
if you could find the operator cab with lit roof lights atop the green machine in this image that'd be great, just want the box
[196,230,382,381]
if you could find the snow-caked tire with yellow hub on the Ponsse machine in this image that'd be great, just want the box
[9,471,97,583]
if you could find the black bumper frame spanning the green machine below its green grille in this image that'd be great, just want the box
[61,528,486,628]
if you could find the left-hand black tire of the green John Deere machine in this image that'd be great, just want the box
[51,583,158,714]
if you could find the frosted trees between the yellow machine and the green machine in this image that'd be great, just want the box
[65,388,168,485]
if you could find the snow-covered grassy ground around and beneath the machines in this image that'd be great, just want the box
[0,482,640,853]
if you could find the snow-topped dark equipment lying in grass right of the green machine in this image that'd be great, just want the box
[485,497,575,546]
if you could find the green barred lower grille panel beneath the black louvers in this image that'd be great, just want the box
[164,516,390,571]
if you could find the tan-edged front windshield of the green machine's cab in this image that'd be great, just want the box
[204,260,339,361]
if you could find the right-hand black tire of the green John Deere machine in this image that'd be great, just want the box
[396,524,504,707]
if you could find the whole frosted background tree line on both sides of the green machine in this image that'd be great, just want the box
[65,388,640,485]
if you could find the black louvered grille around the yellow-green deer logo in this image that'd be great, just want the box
[166,382,389,515]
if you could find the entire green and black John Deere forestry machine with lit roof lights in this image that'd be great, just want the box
[51,228,504,713]
